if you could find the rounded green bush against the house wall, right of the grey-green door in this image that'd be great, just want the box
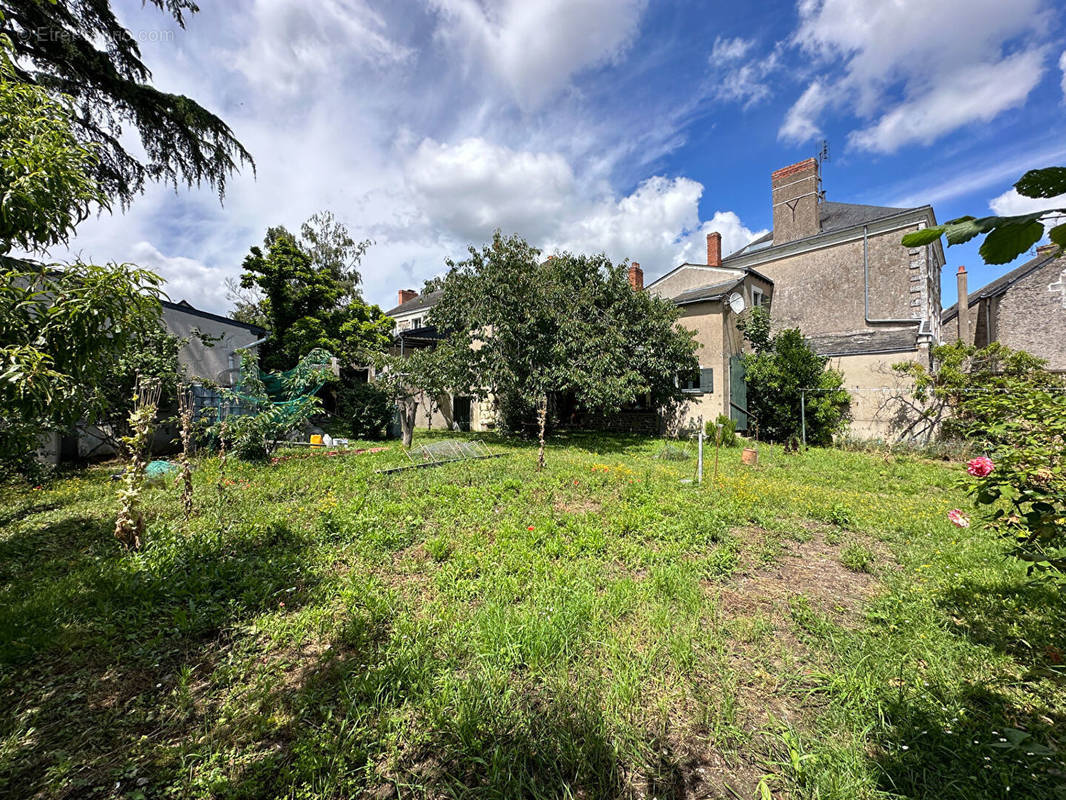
[741,307,851,446]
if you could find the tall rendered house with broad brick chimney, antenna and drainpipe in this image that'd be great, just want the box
[649,158,944,438]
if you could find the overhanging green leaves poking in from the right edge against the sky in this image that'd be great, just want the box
[903,166,1066,263]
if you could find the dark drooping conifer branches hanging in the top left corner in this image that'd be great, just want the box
[0,0,254,204]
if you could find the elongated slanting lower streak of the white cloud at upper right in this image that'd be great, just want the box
[849,50,1044,153]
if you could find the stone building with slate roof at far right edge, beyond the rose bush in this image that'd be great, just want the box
[943,244,1066,372]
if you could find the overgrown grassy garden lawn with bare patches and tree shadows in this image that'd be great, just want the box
[0,432,1066,798]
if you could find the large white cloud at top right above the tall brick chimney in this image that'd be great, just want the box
[780,0,1048,151]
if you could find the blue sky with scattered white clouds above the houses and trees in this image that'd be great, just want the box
[51,0,1066,314]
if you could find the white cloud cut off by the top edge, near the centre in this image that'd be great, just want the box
[431,0,646,111]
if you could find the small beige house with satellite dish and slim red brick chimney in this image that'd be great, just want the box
[631,233,774,431]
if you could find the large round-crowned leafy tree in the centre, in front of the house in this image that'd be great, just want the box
[430,231,696,466]
